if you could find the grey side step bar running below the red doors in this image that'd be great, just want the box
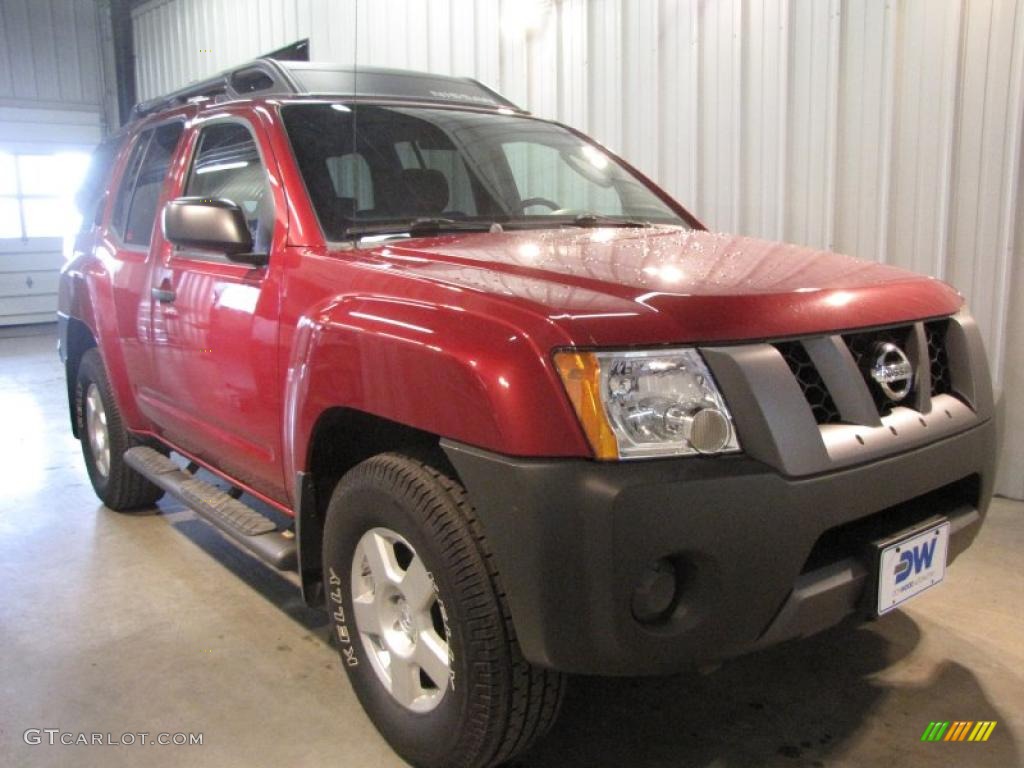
[125,445,297,570]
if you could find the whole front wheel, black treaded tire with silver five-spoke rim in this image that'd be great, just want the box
[323,454,565,768]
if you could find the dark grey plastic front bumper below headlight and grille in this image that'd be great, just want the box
[442,419,995,675]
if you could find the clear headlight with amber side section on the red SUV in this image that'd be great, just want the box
[555,349,739,459]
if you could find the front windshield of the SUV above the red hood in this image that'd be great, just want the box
[282,103,687,241]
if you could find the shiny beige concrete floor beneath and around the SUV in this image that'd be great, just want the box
[0,328,1024,768]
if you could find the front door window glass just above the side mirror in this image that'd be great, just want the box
[185,123,273,253]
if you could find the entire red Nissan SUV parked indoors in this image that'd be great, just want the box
[59,60,994,767]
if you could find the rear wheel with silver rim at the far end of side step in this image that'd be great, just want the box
[75,347,164,512]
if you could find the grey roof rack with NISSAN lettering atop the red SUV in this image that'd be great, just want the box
[131,58,525,120]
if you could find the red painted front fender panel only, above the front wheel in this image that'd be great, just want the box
[283,296,591,487]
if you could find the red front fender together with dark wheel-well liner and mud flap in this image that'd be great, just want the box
[282,295,591,604]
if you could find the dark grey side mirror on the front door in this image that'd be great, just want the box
[162,198,266,265]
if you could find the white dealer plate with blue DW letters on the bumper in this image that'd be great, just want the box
[879,521,949,615]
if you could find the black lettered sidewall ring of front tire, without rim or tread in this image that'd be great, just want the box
[323,478,485,765]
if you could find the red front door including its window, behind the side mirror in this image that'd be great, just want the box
[145,114,287,502]
